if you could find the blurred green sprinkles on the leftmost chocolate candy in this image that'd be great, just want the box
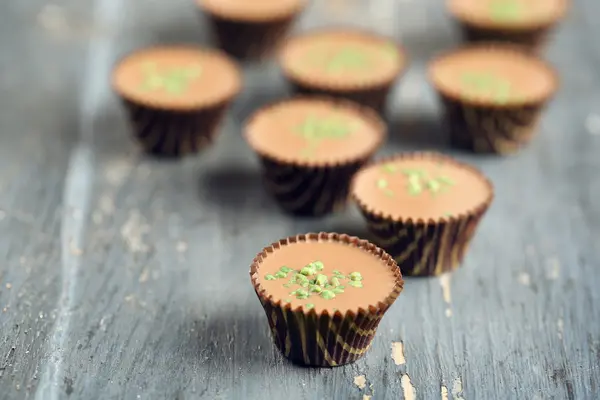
[141,63,202,94]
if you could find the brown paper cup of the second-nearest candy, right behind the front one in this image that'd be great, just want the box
[352,153,494,276]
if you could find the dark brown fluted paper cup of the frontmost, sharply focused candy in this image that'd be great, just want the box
[250,232,404,367]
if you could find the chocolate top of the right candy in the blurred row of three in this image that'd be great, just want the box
[429,45,558,105]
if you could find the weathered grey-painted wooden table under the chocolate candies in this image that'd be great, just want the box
[0,0,600,400]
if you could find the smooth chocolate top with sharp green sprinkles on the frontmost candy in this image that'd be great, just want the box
[257,240,397,313]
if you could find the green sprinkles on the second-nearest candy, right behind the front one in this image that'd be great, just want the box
[377,164,454,196]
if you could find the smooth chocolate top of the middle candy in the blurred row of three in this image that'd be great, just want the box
[280,30,406,89]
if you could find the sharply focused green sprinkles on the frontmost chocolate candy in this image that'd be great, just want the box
[265,261,363,309]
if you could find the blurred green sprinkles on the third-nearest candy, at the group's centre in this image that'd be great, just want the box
[296,115,356,155]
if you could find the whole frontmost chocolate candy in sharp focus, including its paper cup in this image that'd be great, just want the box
[250,232,404,367]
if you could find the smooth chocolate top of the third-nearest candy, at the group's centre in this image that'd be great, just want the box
[245,97,385,165]
